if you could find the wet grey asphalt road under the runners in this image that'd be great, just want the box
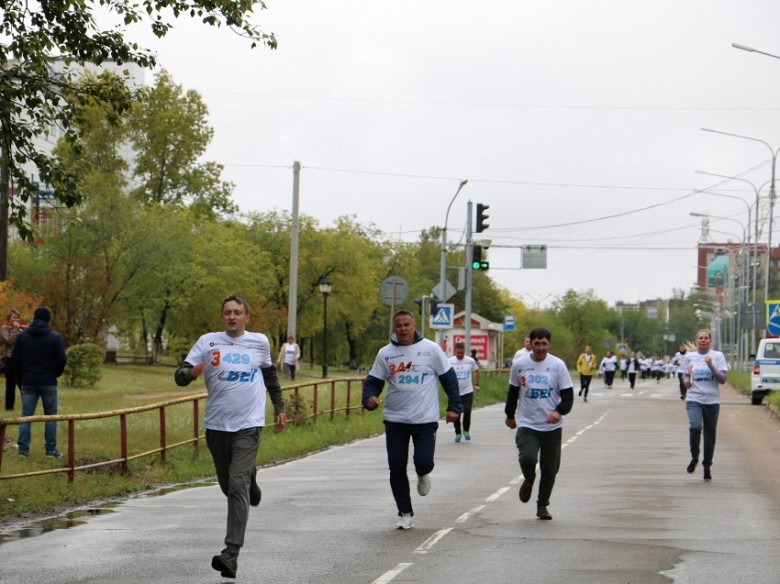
[0,380,780,584]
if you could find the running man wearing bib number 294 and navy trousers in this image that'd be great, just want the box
[363,310,461,529]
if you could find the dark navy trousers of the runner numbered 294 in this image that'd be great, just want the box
[385,421,439,515]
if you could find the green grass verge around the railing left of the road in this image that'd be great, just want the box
[0,365,507,524]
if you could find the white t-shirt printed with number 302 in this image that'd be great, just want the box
[509,353,573,432]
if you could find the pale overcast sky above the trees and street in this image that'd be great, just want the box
[125,0,780,306]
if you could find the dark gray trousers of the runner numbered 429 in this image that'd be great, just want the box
[206,427,262,553]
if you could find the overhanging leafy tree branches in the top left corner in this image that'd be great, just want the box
[0,0,276,280]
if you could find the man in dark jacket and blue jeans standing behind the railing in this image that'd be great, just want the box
[11,306,67,458]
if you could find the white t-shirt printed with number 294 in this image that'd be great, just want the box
[368,339,452,424]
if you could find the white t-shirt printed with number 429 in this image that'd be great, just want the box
[185,332,273,432]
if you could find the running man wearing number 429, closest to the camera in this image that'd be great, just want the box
[174,296,287,578]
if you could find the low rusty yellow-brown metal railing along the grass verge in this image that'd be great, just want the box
[0,377,363,483]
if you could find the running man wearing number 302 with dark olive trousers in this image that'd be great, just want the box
[504,328,574,519]
